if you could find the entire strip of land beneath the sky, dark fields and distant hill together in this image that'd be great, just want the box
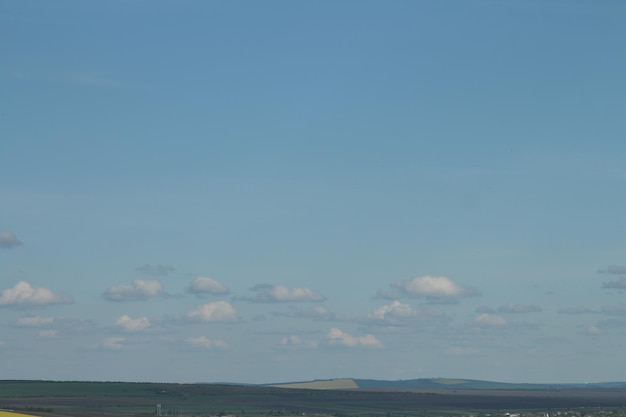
[0,378,626,417]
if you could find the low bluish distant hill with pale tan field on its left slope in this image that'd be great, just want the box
[269,378,626,391]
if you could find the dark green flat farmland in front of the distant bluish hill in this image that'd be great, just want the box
[0,381,626,417]
